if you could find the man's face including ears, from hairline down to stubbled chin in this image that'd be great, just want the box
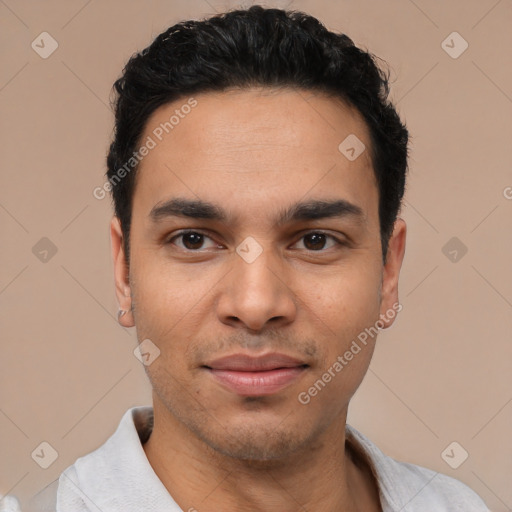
[112,89,404,460]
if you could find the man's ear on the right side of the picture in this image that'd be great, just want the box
[380,218,407,329]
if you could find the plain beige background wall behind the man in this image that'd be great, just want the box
[0,0,512,512]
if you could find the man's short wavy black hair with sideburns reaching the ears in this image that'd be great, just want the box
[106,5,408,261]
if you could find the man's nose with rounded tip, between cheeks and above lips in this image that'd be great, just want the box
[217,243,297,331]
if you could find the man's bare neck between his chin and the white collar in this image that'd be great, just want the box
[144,401,381,512]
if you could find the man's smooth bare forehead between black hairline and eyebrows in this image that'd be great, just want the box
[133,88,378,225]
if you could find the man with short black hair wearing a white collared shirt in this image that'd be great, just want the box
[31,6,487,512]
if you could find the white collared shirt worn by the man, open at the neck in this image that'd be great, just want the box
[31,407,489,512]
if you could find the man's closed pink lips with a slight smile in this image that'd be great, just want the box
[204,353,308,396]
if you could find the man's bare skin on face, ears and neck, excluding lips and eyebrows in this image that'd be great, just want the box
[111,88,406,512]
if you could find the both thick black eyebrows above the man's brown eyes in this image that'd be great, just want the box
[149,198,365,226]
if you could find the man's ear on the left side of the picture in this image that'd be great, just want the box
[110,217,135,327]
